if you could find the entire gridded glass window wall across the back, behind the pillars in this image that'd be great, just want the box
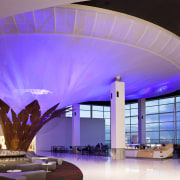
[66,96,180,147]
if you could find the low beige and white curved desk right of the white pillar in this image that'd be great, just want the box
[125,144,173,159]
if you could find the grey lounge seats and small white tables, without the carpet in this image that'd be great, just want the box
[0,151,63,180]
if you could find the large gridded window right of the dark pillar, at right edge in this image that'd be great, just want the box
[146,97,180,143]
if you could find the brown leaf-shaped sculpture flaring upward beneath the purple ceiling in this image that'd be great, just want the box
[0,99,68,151]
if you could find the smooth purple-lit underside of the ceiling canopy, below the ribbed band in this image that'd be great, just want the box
[0,34,180,109]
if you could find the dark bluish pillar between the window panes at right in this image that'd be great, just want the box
[138,99,146,144]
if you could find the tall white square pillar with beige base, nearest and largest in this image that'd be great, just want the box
[111,80,125,159]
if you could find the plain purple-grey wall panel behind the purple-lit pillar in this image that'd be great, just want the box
[36,117,105,152]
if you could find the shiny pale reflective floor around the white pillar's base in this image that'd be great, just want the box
[37,152,180,180]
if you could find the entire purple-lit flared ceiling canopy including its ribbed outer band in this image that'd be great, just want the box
[0,5,180,109]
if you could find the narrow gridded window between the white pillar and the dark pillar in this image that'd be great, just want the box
[125,103,138,144]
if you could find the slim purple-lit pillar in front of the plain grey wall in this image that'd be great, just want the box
[72,104,80,153]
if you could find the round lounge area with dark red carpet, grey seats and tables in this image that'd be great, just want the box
[0,156,83,180]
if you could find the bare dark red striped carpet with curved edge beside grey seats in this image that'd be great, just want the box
[46,161,83,180]
